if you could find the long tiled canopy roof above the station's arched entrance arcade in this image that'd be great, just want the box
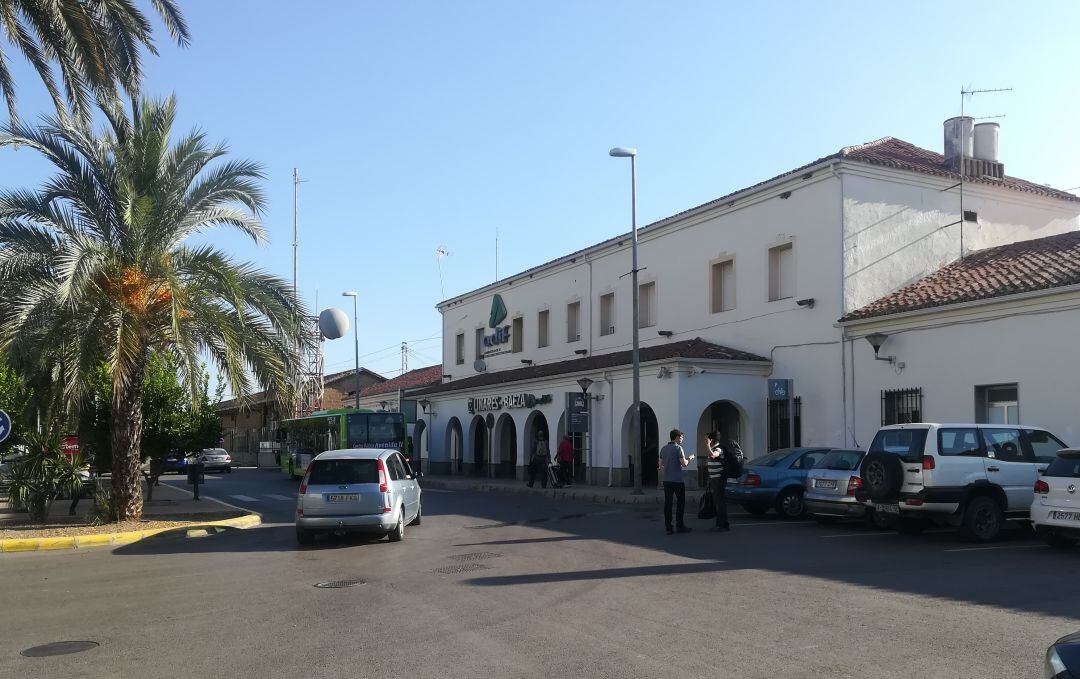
[409,337,769,396]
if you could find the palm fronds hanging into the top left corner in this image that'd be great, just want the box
[0,0,189,123]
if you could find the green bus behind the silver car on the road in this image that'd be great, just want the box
[278,408,410,478]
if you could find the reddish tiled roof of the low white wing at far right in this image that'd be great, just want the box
[840,231,1080,323]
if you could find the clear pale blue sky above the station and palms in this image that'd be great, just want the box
[0,0,1080,386]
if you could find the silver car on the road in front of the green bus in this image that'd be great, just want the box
[296,448,423,544]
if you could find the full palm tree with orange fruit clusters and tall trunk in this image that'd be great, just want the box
[0,97,313,519]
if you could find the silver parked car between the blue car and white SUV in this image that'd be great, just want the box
[804,450,888,528]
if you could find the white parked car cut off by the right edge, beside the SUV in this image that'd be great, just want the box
[1031,448,1080,547]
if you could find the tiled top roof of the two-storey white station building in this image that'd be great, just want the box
[437,137,1080,307]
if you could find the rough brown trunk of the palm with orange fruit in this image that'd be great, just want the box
[111,352,147,521]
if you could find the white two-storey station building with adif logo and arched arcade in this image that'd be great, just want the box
[410,121,1080,485]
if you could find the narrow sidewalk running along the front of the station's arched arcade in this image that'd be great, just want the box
[420,475,701,507]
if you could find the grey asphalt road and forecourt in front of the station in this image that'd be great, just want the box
[0,471,1080,679]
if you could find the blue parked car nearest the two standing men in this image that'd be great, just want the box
[728,448,832,519]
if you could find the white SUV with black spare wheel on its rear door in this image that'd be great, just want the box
[859,423,1065,542]
